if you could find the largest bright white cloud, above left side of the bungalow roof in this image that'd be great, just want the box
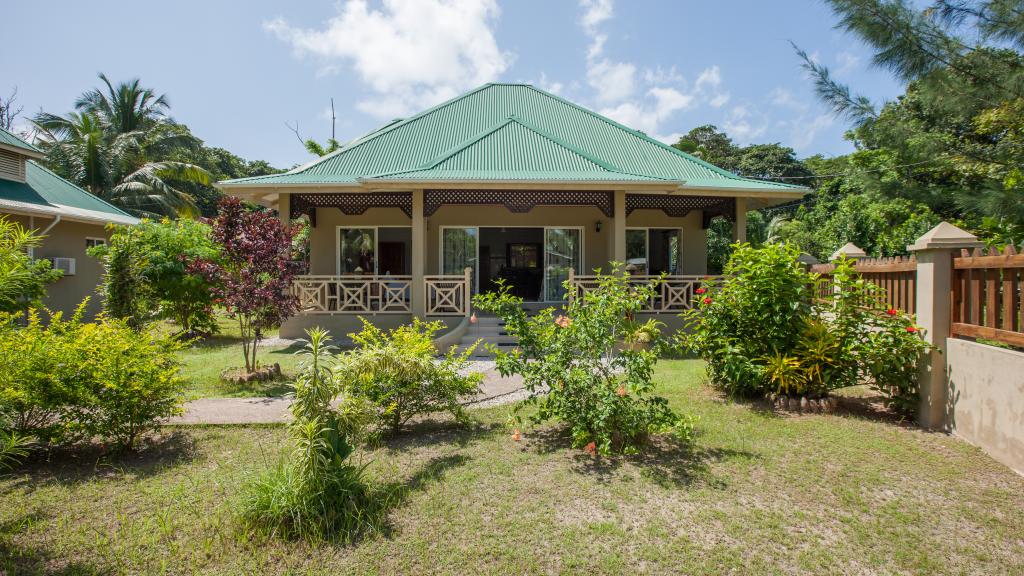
[263,0,513,118]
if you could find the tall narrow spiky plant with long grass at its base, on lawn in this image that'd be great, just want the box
[240,328,372,539]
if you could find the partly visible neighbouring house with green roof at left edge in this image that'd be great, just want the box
[0,128,138,317]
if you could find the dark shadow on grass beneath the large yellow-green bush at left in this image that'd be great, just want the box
[12,429,199,490]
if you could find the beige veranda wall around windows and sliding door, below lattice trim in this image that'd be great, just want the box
[301,201,708,275]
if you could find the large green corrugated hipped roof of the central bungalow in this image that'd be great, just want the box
[220,84,806,192]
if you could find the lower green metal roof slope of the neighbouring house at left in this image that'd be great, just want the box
[0,160,138,223]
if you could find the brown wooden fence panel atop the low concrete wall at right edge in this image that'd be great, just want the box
[950,246,1024,346]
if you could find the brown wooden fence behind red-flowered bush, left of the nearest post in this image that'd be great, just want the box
[811,256,918,314]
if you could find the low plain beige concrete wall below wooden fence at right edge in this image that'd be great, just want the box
[946,338,1024,474]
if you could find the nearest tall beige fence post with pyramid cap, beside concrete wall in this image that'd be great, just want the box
[906,221,983,430]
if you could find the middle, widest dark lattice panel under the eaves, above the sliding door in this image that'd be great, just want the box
[423,190,615,217]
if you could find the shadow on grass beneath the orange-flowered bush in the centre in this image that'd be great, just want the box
[529,426,759,489]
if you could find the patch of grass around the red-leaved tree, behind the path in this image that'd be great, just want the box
[164,317,301,400]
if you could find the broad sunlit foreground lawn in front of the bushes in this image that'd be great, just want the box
[0,361,1024,574]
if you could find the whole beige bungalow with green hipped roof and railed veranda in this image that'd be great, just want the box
[218,83,806,337]
